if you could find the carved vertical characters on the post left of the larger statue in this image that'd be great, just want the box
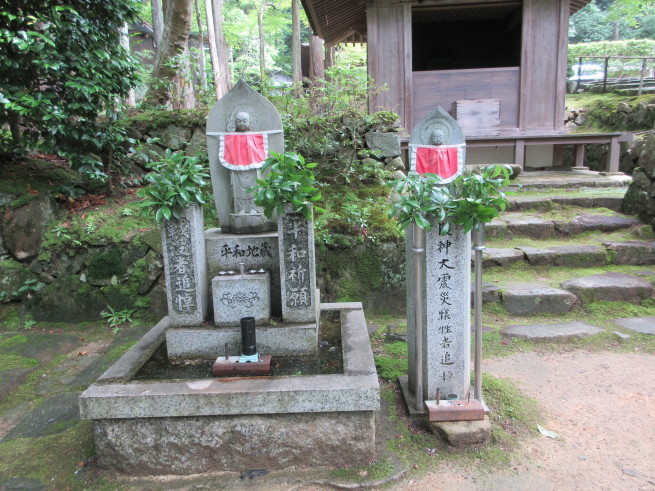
[165,218,197,314]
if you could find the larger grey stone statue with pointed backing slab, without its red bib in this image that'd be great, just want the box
[207,80,284,233]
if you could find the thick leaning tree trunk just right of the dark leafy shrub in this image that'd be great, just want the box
[145,0,193,106]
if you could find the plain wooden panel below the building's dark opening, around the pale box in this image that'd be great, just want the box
[412,67,519,132]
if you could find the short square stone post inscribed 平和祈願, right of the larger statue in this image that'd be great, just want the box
[278,209,318,323]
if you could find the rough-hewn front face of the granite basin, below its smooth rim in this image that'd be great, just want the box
[93,411,375,475]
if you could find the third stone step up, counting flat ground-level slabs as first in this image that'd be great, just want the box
[482,240,655,268]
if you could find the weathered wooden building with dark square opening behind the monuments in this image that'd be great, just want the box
[302,0,632,170]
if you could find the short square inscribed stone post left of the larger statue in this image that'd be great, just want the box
[162,205,208,326]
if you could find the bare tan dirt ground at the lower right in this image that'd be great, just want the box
[404,352,655,490]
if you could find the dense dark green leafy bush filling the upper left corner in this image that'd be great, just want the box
[0,0,137,177]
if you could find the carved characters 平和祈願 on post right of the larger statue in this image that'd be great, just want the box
[280,214,312,309]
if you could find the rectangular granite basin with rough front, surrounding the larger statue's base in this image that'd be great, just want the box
[79,303,380,475]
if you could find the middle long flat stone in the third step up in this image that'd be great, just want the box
[519,245,607,268]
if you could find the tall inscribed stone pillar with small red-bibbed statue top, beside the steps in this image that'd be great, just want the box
[405,107,471,407]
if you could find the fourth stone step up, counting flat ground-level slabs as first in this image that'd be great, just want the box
[485,212,642,239]
